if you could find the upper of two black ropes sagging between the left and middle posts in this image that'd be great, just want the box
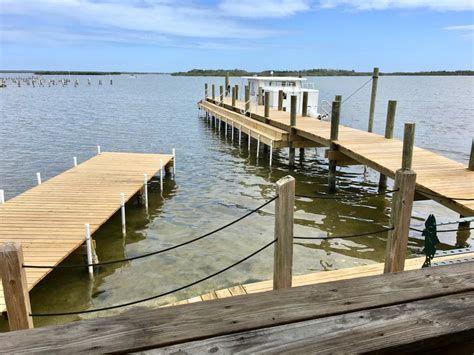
[23,196,278,269]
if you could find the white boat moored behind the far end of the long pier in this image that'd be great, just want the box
[242,76,330,119]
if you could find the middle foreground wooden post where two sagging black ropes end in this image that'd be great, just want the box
[273,176,295,290]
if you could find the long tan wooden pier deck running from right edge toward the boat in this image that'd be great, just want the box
[198,97,474,216]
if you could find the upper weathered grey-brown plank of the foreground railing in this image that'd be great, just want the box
[0,262,474,353]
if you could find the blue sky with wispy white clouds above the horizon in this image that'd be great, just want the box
[0,0,474,72]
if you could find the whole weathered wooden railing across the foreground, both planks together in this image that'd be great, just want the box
[0,262,474,354]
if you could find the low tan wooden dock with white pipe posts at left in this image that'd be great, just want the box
[0,152,173,312]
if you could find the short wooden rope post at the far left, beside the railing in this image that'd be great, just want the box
[0,242,33,331]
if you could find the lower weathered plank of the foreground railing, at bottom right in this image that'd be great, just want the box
[153,292,474,354]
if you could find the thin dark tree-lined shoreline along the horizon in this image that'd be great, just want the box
[0,69,474,77]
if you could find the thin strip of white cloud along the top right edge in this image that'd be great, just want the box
[319,0,474,11]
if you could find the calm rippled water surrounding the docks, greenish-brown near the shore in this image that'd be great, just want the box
[0,75,474,329]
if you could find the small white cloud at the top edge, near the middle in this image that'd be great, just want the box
[218,0,310,18]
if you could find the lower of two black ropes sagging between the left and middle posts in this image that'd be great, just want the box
[30,239,277,317]
